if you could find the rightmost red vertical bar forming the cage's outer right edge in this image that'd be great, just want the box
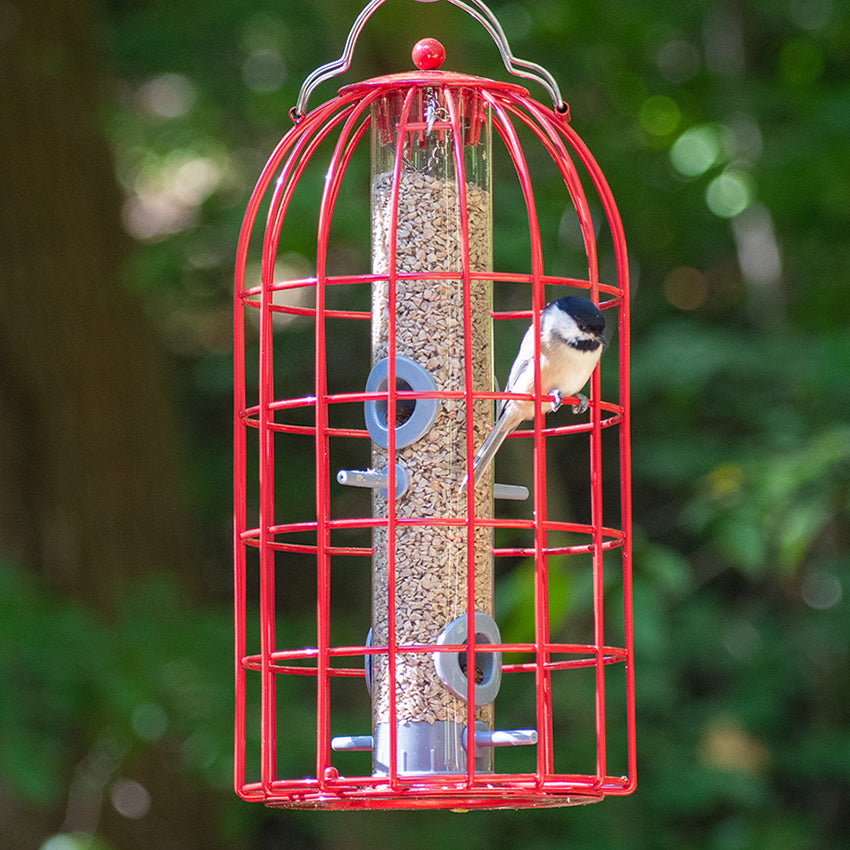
[563,119,637,794]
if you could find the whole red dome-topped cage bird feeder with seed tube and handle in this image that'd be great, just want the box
[234,0,635,810]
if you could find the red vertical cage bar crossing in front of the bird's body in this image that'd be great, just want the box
[492,100,554,785]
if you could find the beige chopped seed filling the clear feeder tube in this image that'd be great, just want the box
[372,171,493,727]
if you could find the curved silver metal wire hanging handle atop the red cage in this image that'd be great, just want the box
[289,0,568,121]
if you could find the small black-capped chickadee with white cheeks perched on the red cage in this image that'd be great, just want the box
[460,295,607,492]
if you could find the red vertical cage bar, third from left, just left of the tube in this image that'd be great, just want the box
[315,100,371,791]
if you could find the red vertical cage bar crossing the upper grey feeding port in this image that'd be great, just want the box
[386,86,416,791]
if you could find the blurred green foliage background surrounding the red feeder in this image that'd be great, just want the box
[0,0,850,850]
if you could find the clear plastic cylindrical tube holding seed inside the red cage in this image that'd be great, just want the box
[372,85,493,774]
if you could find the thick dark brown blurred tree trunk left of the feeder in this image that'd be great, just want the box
[0,0,195,608]
